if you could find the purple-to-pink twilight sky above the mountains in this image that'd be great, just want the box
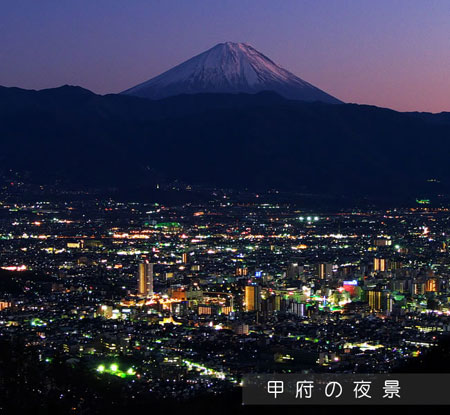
[0,0,450,112]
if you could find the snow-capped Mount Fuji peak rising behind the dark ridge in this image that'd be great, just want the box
[122,42,341,104]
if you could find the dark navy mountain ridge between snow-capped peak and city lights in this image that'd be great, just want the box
[0,86,450,197]
